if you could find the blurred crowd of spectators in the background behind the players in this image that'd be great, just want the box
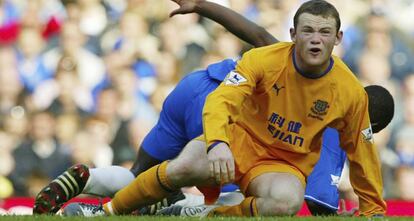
[0,0,414,204]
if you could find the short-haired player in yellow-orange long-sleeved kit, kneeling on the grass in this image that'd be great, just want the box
[63,0,386,216]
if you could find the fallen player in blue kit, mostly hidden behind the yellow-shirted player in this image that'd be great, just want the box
[33,0,394,215]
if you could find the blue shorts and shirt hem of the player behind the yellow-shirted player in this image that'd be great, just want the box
[142,59,236,161]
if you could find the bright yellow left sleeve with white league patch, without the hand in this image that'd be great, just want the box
[203,49,264,146]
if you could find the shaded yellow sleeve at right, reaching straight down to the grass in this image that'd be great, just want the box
[341,92,387,216]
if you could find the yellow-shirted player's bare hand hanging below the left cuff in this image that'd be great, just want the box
[207,142,234,185]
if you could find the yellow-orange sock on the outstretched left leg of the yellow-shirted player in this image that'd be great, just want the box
[104,161,177,214]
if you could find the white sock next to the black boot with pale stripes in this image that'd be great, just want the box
[82,166,135,197]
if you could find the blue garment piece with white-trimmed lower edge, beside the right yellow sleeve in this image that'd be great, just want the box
[305,128,346,210]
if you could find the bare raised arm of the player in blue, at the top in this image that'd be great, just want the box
[170,0,279,47]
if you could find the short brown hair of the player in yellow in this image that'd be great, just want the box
[293,0,341,32]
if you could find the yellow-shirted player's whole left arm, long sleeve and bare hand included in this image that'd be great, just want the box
[203,49,263,183]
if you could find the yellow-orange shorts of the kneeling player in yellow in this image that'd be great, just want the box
[195,126,306,199]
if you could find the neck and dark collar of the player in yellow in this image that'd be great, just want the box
[292,49,334,79]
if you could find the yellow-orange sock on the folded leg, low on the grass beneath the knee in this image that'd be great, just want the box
[208,197,257,216]
